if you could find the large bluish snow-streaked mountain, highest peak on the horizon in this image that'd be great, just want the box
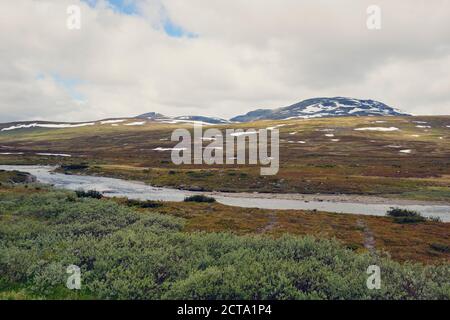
[231,97,409,122]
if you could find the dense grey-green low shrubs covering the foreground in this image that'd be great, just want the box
[0,186,450,300]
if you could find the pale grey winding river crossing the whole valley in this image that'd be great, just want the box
[0,165,450,222]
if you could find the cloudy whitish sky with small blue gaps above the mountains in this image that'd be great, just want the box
[0,0,450,122]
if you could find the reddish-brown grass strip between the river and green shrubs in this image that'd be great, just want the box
[151,203,450,264]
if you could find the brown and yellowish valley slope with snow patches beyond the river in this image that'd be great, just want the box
[0,116,450,203]
